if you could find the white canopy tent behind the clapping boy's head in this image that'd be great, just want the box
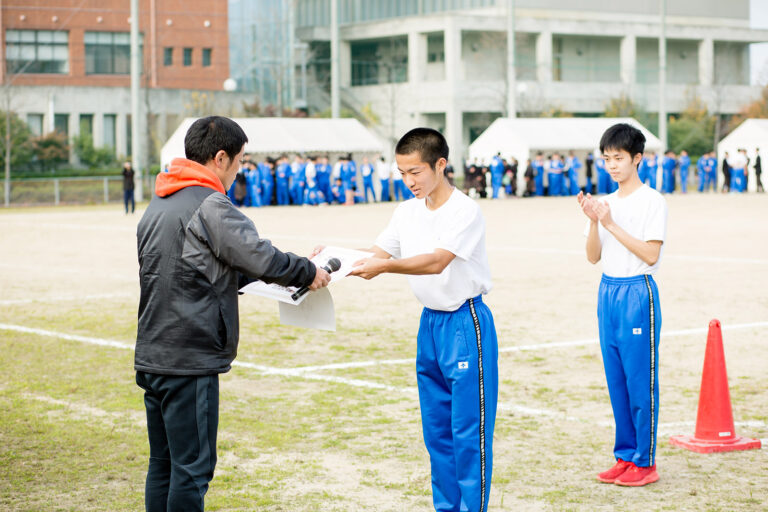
[469,117,662,190]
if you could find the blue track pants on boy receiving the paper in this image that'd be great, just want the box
[416,296,499,512]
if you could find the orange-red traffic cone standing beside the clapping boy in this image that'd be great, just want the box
[669,320,760,453]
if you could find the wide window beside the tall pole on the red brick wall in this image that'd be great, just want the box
[85,32,143,75]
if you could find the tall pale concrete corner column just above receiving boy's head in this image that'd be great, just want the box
[443,17,464,166]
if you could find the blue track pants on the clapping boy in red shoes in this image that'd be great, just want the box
[597,275,661,467]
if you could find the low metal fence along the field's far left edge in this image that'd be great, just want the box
[4,175,155,206]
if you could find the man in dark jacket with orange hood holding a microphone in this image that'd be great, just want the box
[135,116,330,512]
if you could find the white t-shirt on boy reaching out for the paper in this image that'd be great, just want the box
[376,189,493,311]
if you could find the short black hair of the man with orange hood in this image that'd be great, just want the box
[184,116,248,165]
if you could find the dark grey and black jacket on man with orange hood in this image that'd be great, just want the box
[135,161,316,375]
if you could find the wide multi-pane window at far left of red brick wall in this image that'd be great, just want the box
[5,30,69,74]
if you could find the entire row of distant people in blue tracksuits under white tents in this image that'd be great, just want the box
[212,145,763,207]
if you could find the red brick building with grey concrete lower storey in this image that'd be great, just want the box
[0,0,246,164]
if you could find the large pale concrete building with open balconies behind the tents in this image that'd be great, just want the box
[296,0,768,164]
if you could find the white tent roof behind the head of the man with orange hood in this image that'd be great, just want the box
[160,117,384,165]
